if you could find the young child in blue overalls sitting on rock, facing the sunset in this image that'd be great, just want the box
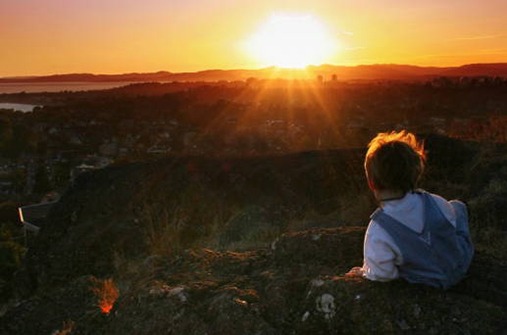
[347,131,474,289]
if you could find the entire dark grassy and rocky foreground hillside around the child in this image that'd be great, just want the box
[0,136,507,334]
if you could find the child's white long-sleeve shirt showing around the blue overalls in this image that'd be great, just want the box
[362,192,456,281]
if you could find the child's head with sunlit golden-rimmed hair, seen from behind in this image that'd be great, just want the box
[364,130,426,192]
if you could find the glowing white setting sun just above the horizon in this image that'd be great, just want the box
[245,14,338,68]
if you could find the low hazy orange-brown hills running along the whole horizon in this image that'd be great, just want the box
[0,63,507,83]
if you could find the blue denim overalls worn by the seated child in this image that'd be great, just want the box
[371,191,474,289]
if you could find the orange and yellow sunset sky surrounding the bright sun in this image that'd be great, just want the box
[0,0,507,77]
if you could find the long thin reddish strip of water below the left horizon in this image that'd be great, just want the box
[0,82,131,94]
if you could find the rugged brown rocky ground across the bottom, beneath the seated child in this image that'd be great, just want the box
[0,227,507,334]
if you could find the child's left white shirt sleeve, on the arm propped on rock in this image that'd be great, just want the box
[363,221,401,281]
